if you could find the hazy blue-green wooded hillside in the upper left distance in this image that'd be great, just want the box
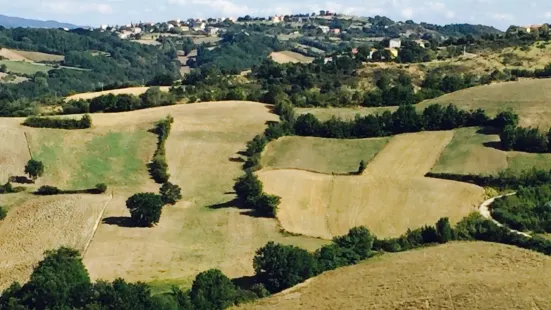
[0,28,179,116]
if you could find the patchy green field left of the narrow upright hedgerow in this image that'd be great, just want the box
[30,130,155,189]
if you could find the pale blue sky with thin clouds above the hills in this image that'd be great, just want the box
[0,0,551,29]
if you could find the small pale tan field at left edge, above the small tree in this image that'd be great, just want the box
[0,119,30,184]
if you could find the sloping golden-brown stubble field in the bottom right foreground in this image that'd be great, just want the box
[238,242,551,310]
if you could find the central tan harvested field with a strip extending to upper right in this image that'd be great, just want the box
[258,131,483,239]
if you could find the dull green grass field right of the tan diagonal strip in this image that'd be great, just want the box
[431,128,551,175]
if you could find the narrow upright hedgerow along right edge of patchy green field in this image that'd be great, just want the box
[148,115,174,184]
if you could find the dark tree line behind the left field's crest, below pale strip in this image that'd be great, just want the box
[62,86,176,114]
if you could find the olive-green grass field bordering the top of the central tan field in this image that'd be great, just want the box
[261,137,390,174]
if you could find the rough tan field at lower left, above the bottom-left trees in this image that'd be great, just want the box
[0,194,111,290]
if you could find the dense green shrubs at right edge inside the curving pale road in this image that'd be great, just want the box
[490,184,551,233]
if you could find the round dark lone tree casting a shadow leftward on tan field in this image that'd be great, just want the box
[126,193,164,227]
